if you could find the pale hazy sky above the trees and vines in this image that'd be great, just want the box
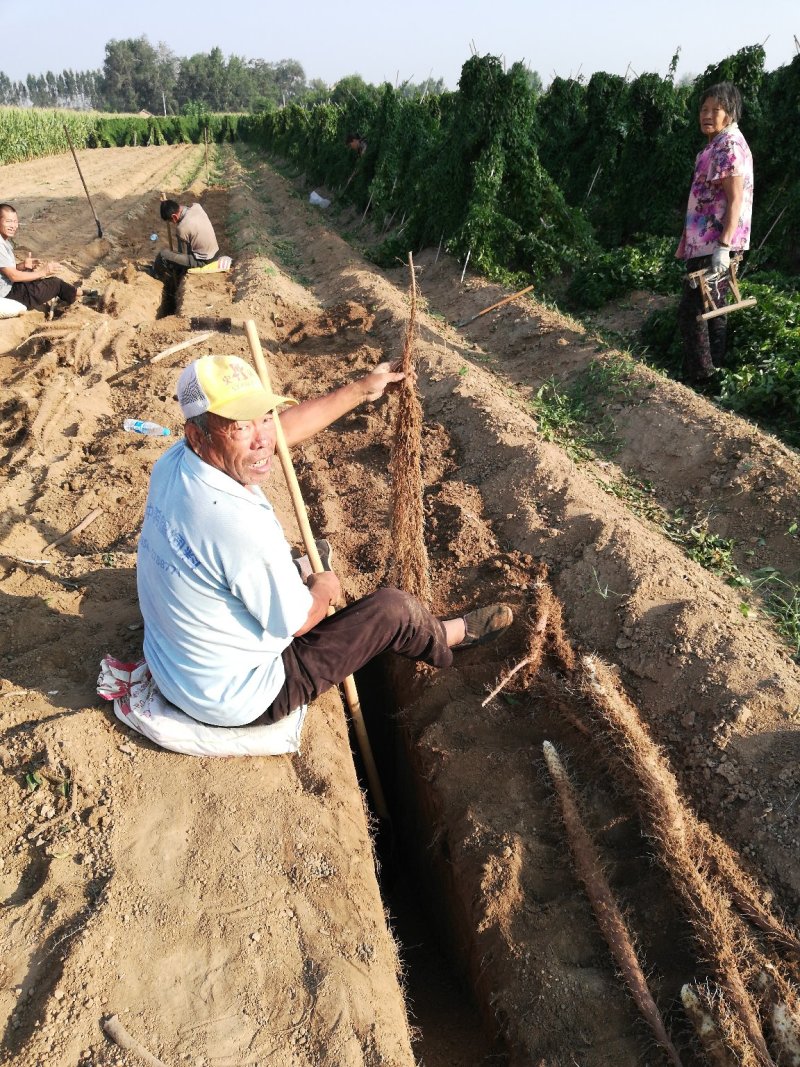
[0,0,800,89]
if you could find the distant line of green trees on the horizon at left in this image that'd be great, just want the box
[0,36,445,115]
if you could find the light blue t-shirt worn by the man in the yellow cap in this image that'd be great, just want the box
[137,441,313,726]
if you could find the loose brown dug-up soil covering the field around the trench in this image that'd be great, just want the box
[0,146,800,1067]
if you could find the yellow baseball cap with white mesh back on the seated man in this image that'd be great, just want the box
[178,355,298,421]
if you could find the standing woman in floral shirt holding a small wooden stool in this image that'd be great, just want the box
[675,81,753,382]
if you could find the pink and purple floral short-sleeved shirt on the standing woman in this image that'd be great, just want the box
[675,123,753,259]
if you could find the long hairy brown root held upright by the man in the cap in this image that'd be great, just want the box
[391,252,431,605]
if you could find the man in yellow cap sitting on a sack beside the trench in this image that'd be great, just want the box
[137,355,512,727]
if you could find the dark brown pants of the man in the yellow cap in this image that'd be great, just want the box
[260,588,452,726]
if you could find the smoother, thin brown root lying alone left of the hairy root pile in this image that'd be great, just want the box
[542,740,681,1067]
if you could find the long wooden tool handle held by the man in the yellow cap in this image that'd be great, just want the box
[244,319,389,818]
